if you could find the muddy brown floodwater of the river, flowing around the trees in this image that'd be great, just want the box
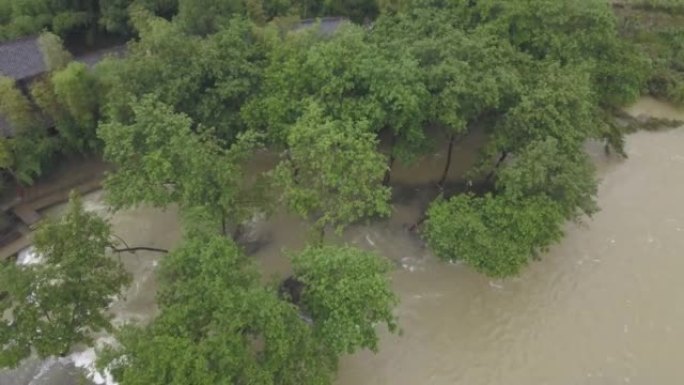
[0,98,684,385]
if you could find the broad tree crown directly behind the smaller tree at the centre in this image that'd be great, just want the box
[246,24,428,179]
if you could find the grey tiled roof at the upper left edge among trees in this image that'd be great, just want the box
[0,36,46,80]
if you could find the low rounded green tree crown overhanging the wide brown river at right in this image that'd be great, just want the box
[424,194,564,277]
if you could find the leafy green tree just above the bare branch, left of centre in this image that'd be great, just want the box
[99,96,258,231]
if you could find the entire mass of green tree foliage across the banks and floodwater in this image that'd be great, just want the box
[0,0,684,385]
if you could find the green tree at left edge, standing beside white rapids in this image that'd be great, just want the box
[0,197,130,367]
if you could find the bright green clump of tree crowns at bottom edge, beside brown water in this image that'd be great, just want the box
[102,236,396,385]
